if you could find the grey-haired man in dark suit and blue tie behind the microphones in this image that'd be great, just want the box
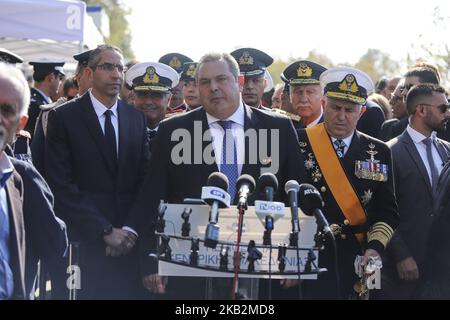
[133,54,304,299]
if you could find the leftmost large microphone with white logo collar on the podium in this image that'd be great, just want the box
[201,172,230,249]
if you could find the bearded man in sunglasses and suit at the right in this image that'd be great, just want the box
[380,84,450,299]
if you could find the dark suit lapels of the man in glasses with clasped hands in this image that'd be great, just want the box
[80,93,120,175]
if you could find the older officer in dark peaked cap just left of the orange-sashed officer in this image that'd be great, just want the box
[281,60,327,129]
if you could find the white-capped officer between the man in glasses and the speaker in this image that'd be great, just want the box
[125,62,180,153]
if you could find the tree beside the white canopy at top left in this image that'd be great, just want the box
[84,0,134,60]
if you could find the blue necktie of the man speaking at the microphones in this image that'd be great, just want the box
[217,120,238,201]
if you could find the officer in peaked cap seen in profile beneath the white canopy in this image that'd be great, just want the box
[25,59,65,136]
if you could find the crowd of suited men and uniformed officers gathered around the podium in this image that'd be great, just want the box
[0,45,450,299]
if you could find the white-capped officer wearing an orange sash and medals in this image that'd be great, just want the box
[299,67,399,299]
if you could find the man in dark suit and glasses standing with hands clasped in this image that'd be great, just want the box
[45,45,148,299]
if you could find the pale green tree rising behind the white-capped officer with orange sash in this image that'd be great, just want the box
[355,49,400,83]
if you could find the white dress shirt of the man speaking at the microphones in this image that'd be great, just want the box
[206,101,245,176]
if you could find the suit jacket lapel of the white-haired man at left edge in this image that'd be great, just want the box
[6,171,25,294]
